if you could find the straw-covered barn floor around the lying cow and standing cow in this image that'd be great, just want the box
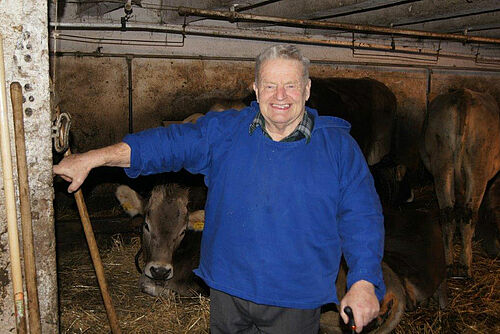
[56,185,500,334]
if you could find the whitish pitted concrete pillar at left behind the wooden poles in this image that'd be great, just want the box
[0,0,58,333]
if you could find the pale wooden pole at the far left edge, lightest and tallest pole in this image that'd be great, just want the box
[0,35,26,334]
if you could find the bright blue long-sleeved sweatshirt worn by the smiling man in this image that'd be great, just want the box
[124,102,385,309]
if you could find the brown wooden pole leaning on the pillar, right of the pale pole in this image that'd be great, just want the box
[10,82,42,334]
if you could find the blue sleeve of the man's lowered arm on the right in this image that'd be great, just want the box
[338,137,385,300]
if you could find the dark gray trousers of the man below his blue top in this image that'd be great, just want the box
[210,289,320,334]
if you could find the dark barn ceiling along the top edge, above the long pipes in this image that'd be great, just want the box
[59,0,500,38]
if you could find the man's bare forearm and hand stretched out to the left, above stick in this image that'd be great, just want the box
[53,142,131,193]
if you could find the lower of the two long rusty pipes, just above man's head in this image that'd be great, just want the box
[50,23,500,64]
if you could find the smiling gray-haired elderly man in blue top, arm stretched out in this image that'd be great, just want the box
[54,45,385,334]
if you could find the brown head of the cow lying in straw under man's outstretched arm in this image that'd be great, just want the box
[116,184,204,296]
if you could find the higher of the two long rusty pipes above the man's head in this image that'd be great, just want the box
[177,7,500,44]
